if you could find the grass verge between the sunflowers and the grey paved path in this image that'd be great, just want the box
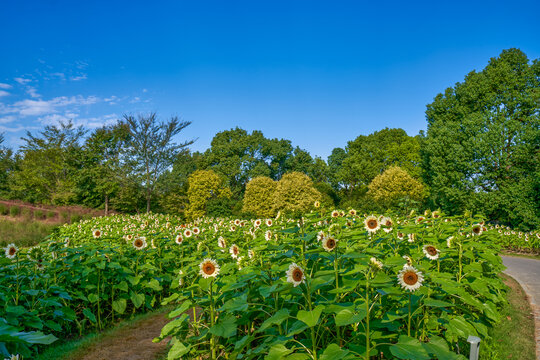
[480,274,536,360]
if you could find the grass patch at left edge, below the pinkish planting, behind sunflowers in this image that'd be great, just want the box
[0,219,58,247]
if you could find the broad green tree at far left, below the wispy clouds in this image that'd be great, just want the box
[9,121,86,204]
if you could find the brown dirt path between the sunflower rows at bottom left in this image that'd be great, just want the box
[77,313,170,360]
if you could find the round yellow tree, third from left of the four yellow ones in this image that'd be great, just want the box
[274,172,321,216]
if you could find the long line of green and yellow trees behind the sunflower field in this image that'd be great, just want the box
[0,49,540,229]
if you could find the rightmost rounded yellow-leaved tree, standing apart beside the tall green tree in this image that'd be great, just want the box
[368,166,425,208]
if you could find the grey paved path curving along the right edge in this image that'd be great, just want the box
[501,256,540,360]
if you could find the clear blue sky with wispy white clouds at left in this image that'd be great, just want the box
[0,0,540,159]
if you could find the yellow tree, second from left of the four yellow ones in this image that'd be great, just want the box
[242,176,277,218]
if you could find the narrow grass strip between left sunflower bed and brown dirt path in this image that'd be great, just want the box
[35,306,173,360]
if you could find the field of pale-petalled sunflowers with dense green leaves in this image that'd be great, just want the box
[0,208,524,360]
